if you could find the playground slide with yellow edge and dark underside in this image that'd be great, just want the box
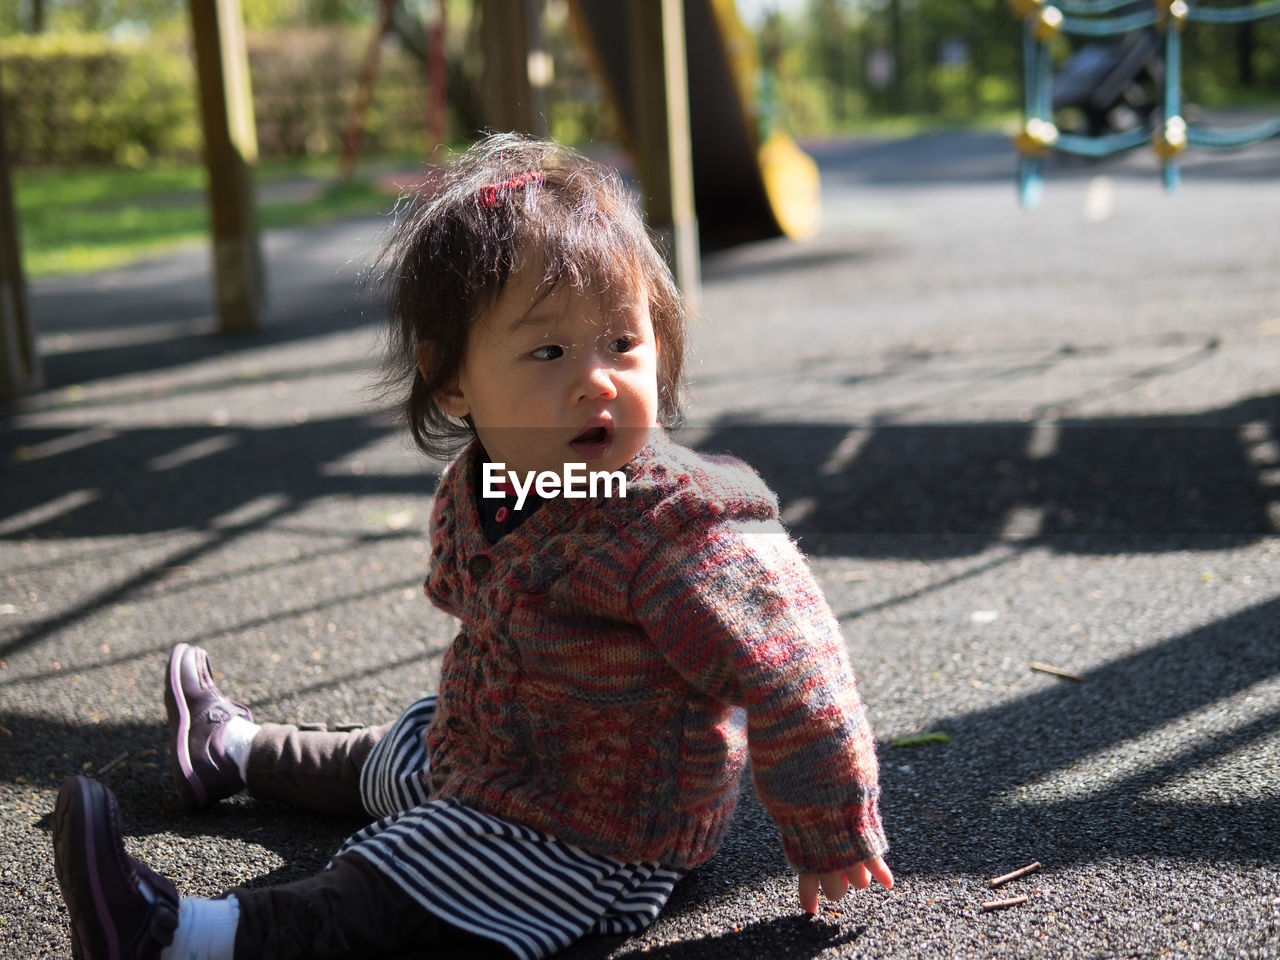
[572,0,819,250]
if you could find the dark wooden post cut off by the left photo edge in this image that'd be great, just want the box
[0,64,42,401]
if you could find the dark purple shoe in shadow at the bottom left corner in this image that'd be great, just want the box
[54,777,178,960]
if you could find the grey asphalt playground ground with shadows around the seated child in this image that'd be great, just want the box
[0,124,1280,960]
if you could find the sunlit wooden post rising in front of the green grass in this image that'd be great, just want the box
[191,0,264,333]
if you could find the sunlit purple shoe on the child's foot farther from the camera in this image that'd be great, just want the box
[164,644,253,813]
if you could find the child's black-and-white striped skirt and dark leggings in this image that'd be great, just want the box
[236,696,685,960]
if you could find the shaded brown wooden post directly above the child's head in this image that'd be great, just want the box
[479,0,547,137]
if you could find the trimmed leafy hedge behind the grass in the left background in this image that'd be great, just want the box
[0,28,428,166]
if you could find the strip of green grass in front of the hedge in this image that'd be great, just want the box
[14,161,394,276]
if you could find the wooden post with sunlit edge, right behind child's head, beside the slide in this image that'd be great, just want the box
[627,0,701,310]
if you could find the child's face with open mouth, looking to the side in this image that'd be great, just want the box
[436,268,658,476]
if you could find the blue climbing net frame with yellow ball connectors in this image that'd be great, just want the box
[1009,0,1280,207]
